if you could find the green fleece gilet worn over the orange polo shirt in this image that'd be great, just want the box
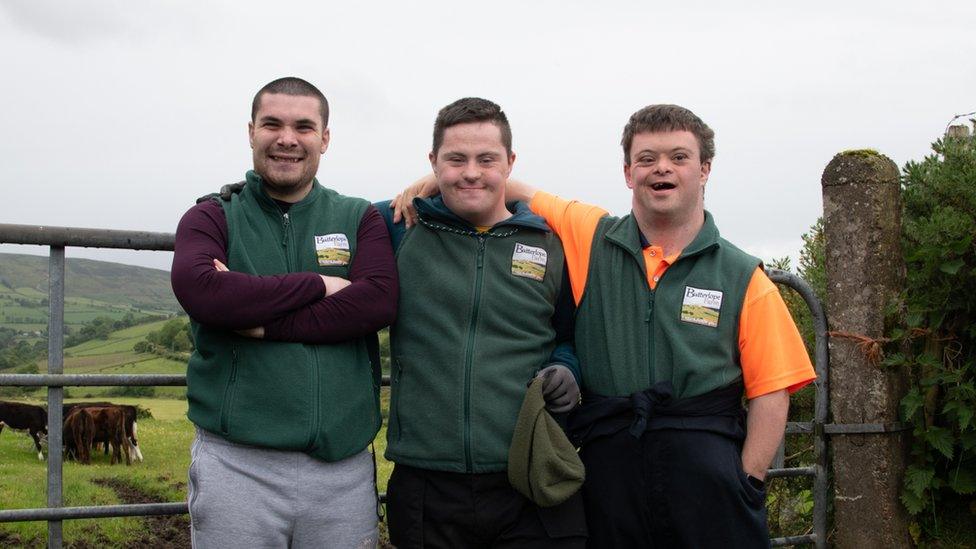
[576,212,762,398]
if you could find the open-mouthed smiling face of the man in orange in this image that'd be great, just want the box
[624,130,711,225]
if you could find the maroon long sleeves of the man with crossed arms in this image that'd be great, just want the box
[171,200,398,343]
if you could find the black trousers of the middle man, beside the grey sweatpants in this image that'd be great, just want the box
[386,464,586,549]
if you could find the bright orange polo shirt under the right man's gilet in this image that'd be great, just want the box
[529,191,817,398]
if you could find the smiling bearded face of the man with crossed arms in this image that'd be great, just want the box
[247,93,329,202]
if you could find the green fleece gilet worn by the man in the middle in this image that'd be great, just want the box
[386,198,564,473]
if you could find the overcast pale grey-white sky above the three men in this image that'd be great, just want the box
[0,0,976,268]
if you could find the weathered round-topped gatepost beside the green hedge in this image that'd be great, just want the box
[821,150,912,549]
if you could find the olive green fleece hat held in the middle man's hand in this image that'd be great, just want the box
[508,378,585,507]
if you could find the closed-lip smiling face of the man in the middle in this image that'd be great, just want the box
[430,122,515,227]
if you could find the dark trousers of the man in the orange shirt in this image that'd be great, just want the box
[580,429,769,549]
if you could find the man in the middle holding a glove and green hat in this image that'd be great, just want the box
[379,98,586,549]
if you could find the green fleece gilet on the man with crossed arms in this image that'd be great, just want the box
[187,172,381,461]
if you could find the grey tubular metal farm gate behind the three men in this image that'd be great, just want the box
[0,224,829,549]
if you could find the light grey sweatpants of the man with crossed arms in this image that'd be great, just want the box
[189,428,378,549]
